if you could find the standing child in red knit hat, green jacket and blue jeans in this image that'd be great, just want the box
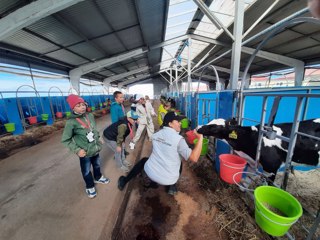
[61,94,110,198]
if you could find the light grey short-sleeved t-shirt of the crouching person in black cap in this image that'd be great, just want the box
[144,127,192,185]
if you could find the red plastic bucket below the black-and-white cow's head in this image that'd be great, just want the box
[219,154,247,184]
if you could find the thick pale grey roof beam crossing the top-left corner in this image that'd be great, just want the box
[0,0,83,41]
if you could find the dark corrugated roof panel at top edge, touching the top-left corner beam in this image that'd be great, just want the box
[59,1,112,38]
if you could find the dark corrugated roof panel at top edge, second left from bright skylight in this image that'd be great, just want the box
[96,0,138,30]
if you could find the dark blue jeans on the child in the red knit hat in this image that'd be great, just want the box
[80,154,102,188]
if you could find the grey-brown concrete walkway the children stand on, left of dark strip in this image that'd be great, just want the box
[0,115,141,240]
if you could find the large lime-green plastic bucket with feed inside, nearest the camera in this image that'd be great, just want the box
[254,186,302,237]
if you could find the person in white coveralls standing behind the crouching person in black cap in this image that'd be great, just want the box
[129,94,156,149]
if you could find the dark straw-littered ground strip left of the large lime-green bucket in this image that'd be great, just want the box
[192,158,272,240]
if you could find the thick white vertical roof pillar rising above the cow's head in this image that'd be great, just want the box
[228,0,244,89]
